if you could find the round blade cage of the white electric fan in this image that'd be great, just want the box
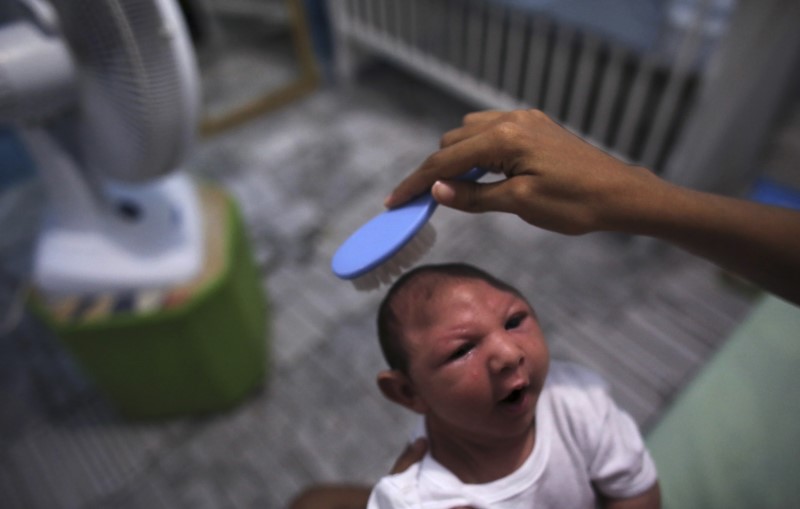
[53,0,197,181]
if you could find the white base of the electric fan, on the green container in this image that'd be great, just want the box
[33,172,204,295]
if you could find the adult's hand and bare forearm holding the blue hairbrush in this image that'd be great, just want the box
[386,110,800,305]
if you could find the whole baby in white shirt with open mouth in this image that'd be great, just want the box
[369,264,660,509]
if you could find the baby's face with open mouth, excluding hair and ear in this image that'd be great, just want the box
[403,279,549,439]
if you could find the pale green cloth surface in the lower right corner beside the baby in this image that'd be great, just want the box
[647,296,800,509]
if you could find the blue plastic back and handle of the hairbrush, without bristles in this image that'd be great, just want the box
[331,168,486,279]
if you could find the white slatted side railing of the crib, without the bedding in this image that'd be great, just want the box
[329,0,724,171]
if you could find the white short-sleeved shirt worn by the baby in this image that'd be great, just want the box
[368,361,657,509]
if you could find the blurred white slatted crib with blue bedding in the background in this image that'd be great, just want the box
[328,0,800,190]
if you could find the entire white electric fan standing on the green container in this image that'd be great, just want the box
[0,0,203,295]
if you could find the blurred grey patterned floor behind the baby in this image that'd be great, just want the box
[0,61,764,509]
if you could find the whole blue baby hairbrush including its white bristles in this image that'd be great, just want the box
[331,168,486,290]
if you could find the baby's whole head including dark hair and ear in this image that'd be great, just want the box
[378,264,549,438]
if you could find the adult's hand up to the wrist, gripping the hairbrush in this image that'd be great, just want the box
[385,110,664,234]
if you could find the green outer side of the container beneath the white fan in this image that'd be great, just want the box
[32,186,268,418]
